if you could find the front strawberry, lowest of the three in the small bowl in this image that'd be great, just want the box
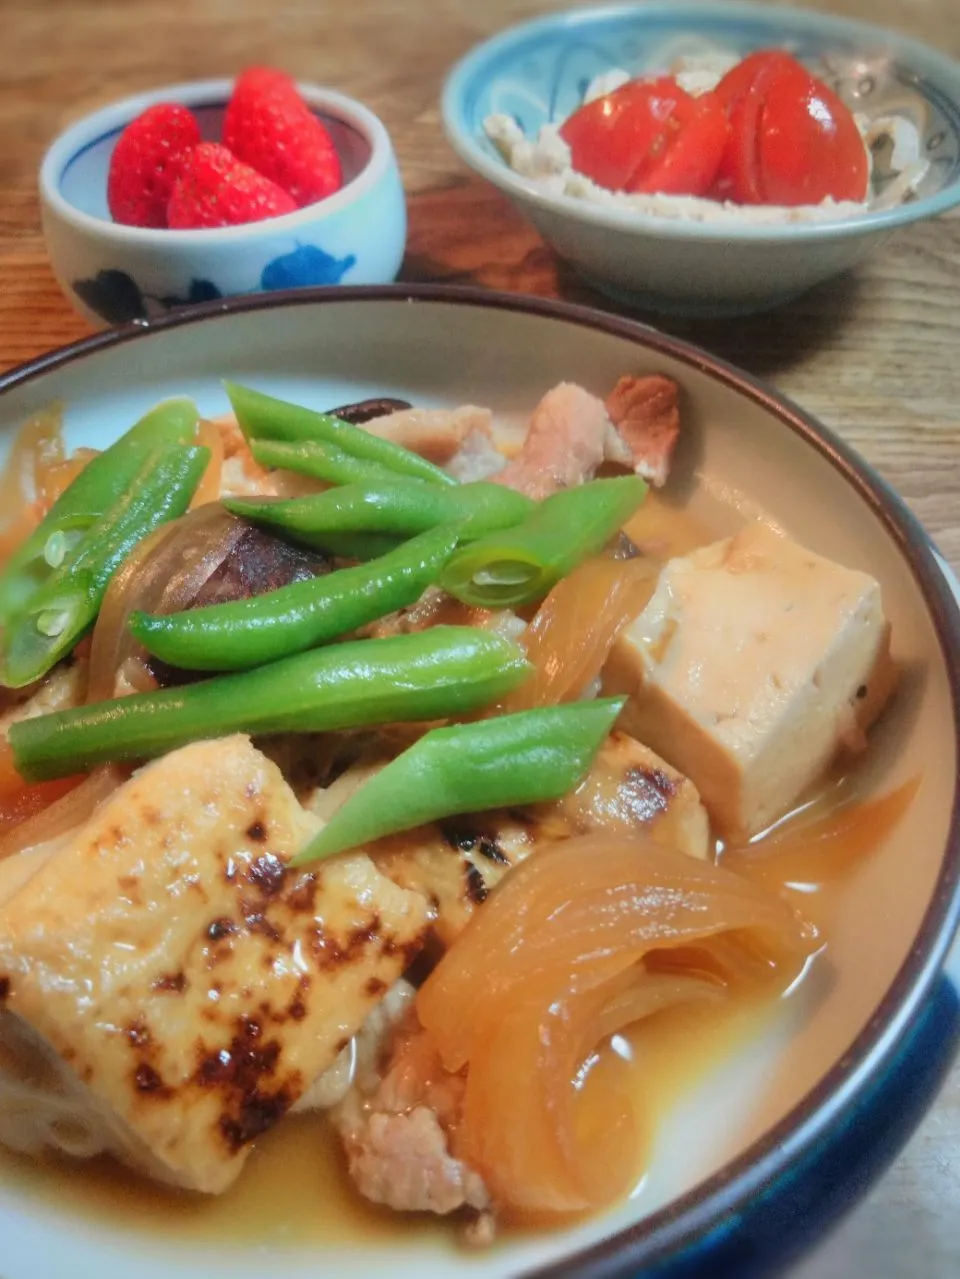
[166,142,297,230]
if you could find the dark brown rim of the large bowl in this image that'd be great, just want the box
[0,284,960,1279]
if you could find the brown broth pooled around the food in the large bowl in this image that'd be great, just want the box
[0,492,918,1247]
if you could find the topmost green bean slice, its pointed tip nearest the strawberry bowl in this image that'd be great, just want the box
[224,382,456,485]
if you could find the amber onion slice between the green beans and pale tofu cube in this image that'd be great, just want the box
[502,558,658,712]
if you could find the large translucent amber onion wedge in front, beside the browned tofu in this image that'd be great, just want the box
[417,835,817,1214]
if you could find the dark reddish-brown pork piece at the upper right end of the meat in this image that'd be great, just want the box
[606,375,680,489]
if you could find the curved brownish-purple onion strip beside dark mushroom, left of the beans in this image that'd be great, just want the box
[87,503,245,702]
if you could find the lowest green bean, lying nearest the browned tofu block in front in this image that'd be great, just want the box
[293,697,626,866]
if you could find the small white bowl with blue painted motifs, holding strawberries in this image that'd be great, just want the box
[40,79,406,325]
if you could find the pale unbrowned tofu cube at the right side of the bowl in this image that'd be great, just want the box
[603,523,894,836]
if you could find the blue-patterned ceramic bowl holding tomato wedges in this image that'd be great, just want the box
[442,0,960,315]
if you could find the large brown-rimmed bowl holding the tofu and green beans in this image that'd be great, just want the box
[0,288,960,1279]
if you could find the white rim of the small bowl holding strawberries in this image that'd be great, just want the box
[38,77,394,249]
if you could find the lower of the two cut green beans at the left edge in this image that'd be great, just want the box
[3,448,210,688]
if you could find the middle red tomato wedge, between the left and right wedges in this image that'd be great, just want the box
[626,95,730,196]
